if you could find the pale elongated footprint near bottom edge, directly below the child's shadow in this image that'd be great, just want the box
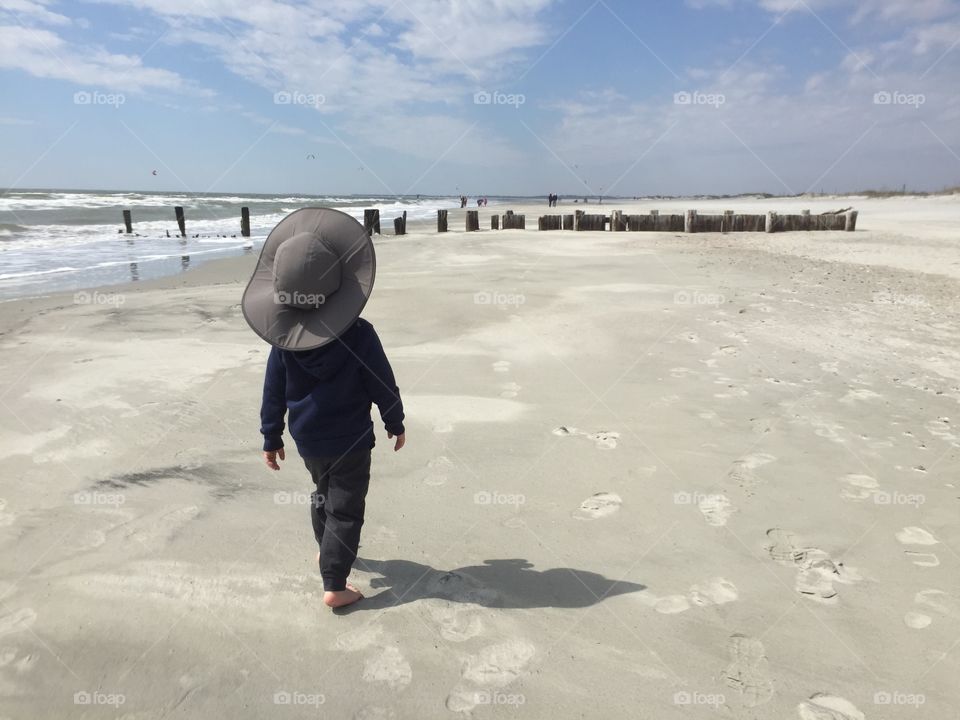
[446,640,536,712]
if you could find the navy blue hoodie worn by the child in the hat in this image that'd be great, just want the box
[260,318,404,457]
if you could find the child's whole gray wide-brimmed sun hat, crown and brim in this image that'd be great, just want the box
[241,208,377,350]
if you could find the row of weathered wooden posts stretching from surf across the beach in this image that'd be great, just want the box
[123,205,857,237]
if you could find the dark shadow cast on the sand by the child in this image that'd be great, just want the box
[350,558,646,610]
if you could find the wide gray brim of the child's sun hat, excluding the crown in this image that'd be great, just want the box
[240,208,377,350]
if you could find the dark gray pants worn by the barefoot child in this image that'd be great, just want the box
[303,449,370,590]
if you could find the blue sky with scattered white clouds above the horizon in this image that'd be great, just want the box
[0,0,960,197]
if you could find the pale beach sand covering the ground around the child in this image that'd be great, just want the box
[0,198,960,720]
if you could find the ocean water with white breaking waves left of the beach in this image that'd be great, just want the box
[0,190,468,299]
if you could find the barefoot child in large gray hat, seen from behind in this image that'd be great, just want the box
[241,208,406,608]
